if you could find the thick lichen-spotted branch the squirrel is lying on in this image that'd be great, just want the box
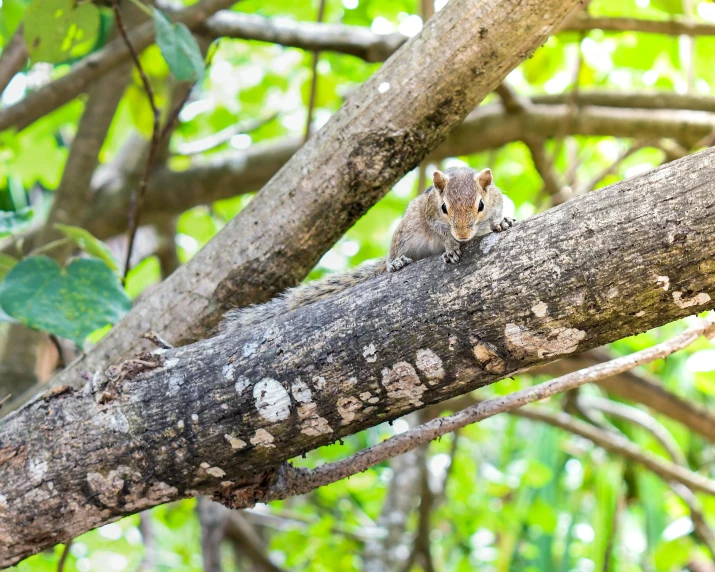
[0,146,715,565]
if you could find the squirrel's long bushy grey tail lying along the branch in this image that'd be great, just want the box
[219,259,386,332]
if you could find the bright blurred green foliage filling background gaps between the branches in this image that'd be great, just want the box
[0,0,715,572]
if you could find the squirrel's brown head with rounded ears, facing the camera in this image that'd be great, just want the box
[433,168,494,242]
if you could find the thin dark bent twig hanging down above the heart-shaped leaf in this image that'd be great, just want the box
[113,0,161,282]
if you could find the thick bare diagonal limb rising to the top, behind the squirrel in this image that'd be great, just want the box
[46,0,578,384]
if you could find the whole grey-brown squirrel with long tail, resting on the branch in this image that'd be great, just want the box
[219,167,514,332]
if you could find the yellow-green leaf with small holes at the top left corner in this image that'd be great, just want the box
[24,0,100,63]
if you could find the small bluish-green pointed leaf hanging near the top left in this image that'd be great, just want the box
[154,10,206,82]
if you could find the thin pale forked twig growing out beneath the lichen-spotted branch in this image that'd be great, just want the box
[246,317,715,502]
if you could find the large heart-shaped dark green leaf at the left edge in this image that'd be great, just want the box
[0,256,132,346]
